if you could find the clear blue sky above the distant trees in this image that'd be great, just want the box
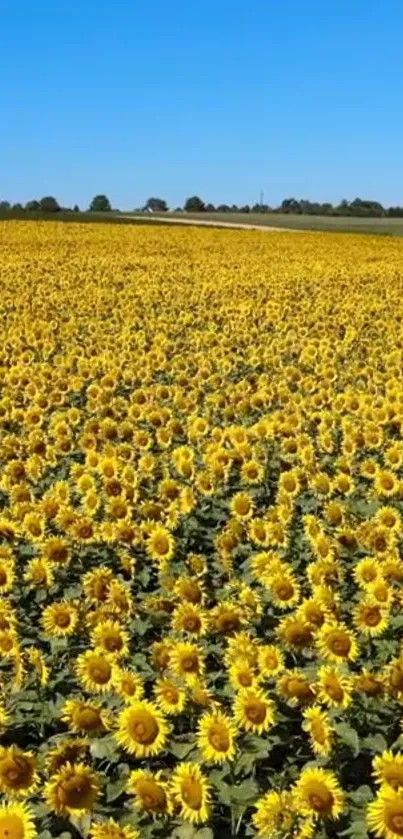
[0,0,403,209]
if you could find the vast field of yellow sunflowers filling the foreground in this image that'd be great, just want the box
[0,221,403,839]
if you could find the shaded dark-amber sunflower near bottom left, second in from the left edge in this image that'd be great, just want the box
[44,763,101,816]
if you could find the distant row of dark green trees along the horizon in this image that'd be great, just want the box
[0,194,403,218]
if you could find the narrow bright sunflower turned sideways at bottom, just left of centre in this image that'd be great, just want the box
[171,763,211,824]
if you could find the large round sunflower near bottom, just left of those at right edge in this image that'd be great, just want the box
[293,767,345,819]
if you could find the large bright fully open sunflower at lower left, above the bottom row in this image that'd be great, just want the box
[115,701,168,758]
